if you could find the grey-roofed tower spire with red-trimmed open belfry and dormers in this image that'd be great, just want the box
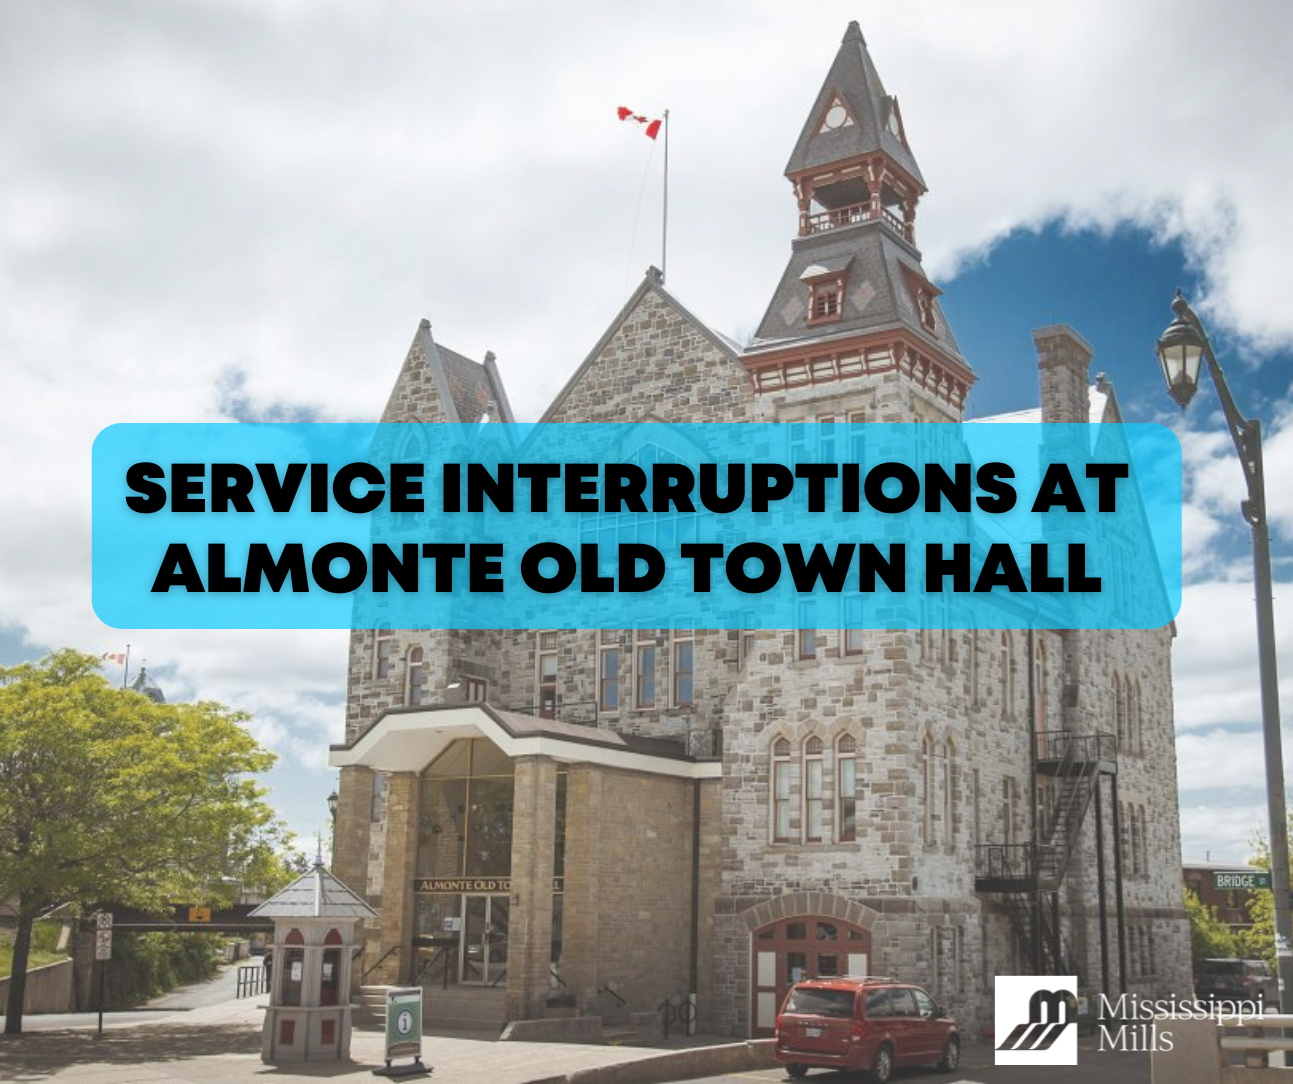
[745,22,974,420]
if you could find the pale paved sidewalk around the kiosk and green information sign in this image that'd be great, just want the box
[0,996,765,1084]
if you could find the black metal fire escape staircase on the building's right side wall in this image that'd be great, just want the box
[975,731,1117,977]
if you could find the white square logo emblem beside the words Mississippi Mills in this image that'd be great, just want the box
[996,975,1077,1065]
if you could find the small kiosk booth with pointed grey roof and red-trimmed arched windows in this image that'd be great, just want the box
[251,863,378,1065]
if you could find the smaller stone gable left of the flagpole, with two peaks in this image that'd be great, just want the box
[381,320,513,422]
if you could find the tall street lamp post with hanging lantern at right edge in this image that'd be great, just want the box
[1159,290,1293,1013]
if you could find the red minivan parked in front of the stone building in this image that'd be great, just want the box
[772,978,961,1084]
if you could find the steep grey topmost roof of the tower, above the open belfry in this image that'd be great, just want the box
[786,22,924,188]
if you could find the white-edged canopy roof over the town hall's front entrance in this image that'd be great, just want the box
[328,704,723,779]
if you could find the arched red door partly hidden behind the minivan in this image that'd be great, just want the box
[750,915,871,1036]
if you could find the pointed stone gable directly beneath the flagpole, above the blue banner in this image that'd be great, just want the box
[540,268,754,422]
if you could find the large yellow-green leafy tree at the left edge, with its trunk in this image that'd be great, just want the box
[0,651,283,1035]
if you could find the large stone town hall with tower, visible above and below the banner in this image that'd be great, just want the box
[332,16,1190,1035]
